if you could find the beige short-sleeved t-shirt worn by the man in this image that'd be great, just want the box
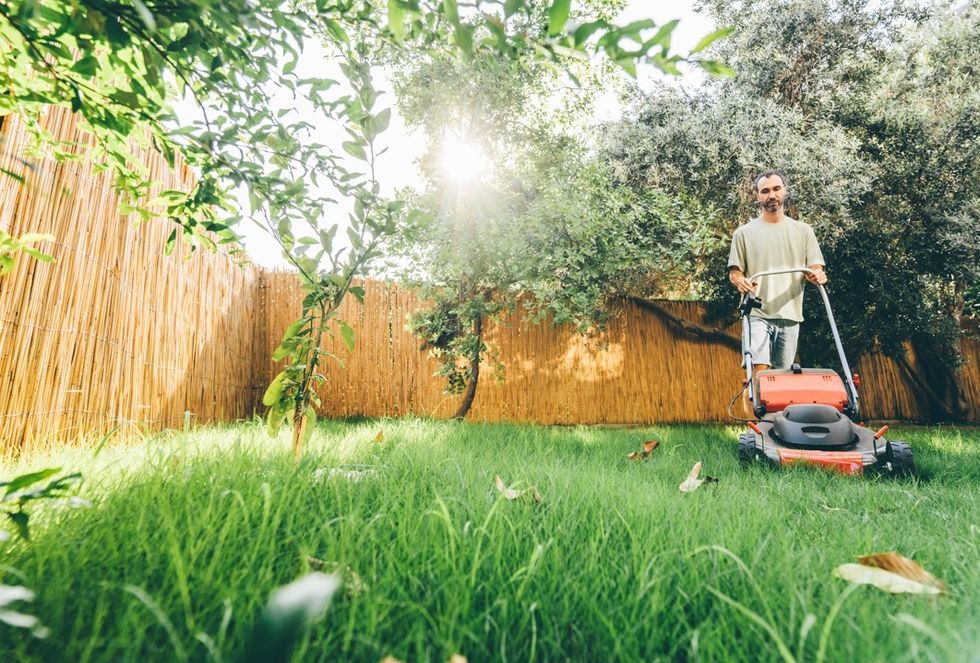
[728,216,824,322]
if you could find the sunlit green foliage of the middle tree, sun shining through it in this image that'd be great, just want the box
[394,7,736,417]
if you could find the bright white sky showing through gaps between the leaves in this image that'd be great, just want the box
[231,0,712,267]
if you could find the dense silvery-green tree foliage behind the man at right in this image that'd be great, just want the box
[607,0,980,417]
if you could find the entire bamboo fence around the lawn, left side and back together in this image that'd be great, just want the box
[0,110,980,449]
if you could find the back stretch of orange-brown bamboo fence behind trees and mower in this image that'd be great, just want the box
[262,272,980,424]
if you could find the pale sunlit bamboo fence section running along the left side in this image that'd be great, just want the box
[0,109,265,449]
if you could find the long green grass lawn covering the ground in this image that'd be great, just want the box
[0,420,980,663]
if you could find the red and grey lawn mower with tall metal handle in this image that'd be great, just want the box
[732,267,915,476]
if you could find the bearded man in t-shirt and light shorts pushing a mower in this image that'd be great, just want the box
[728,170,827,370]
